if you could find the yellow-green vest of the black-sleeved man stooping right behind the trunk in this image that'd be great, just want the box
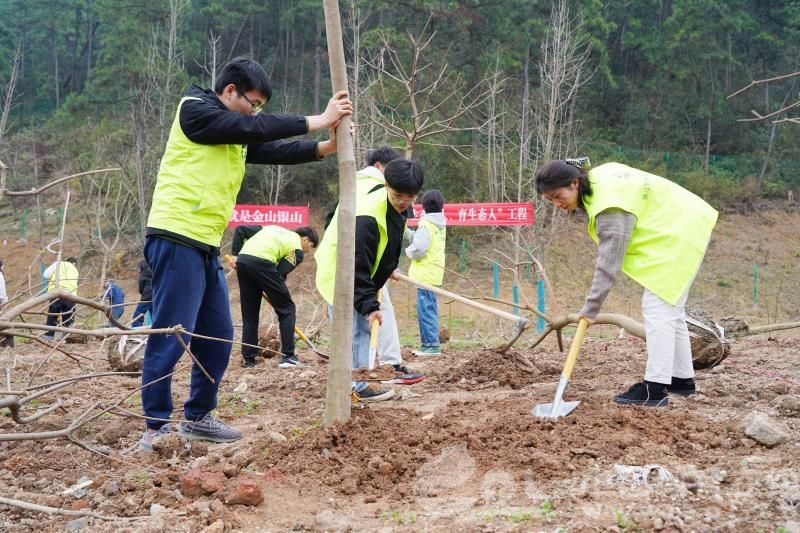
[314,188,389,305]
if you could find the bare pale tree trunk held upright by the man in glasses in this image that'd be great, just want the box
[323,0,356,426]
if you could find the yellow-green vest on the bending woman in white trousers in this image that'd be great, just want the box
[584,163,718,305]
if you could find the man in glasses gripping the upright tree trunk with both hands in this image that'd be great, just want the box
[139,59,352,450]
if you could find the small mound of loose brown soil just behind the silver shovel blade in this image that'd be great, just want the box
[437,350,561,389]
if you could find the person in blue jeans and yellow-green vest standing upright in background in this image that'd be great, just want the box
[406,190,447,356]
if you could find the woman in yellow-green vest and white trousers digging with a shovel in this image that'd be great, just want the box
[536,157,717,407]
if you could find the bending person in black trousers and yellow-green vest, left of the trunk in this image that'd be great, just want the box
[231,222,319,368]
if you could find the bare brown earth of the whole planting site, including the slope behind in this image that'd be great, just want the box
[0,210,800,531]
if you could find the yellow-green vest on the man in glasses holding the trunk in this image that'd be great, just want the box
[147,97,247,247]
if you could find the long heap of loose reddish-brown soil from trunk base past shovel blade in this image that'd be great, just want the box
[254,399,735,500]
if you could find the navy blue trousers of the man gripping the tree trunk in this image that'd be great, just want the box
[142,237,233,429]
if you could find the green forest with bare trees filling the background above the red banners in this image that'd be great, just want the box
[0,0,800,231]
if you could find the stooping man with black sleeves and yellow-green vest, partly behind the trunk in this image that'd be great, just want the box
[314,159,423,402]
